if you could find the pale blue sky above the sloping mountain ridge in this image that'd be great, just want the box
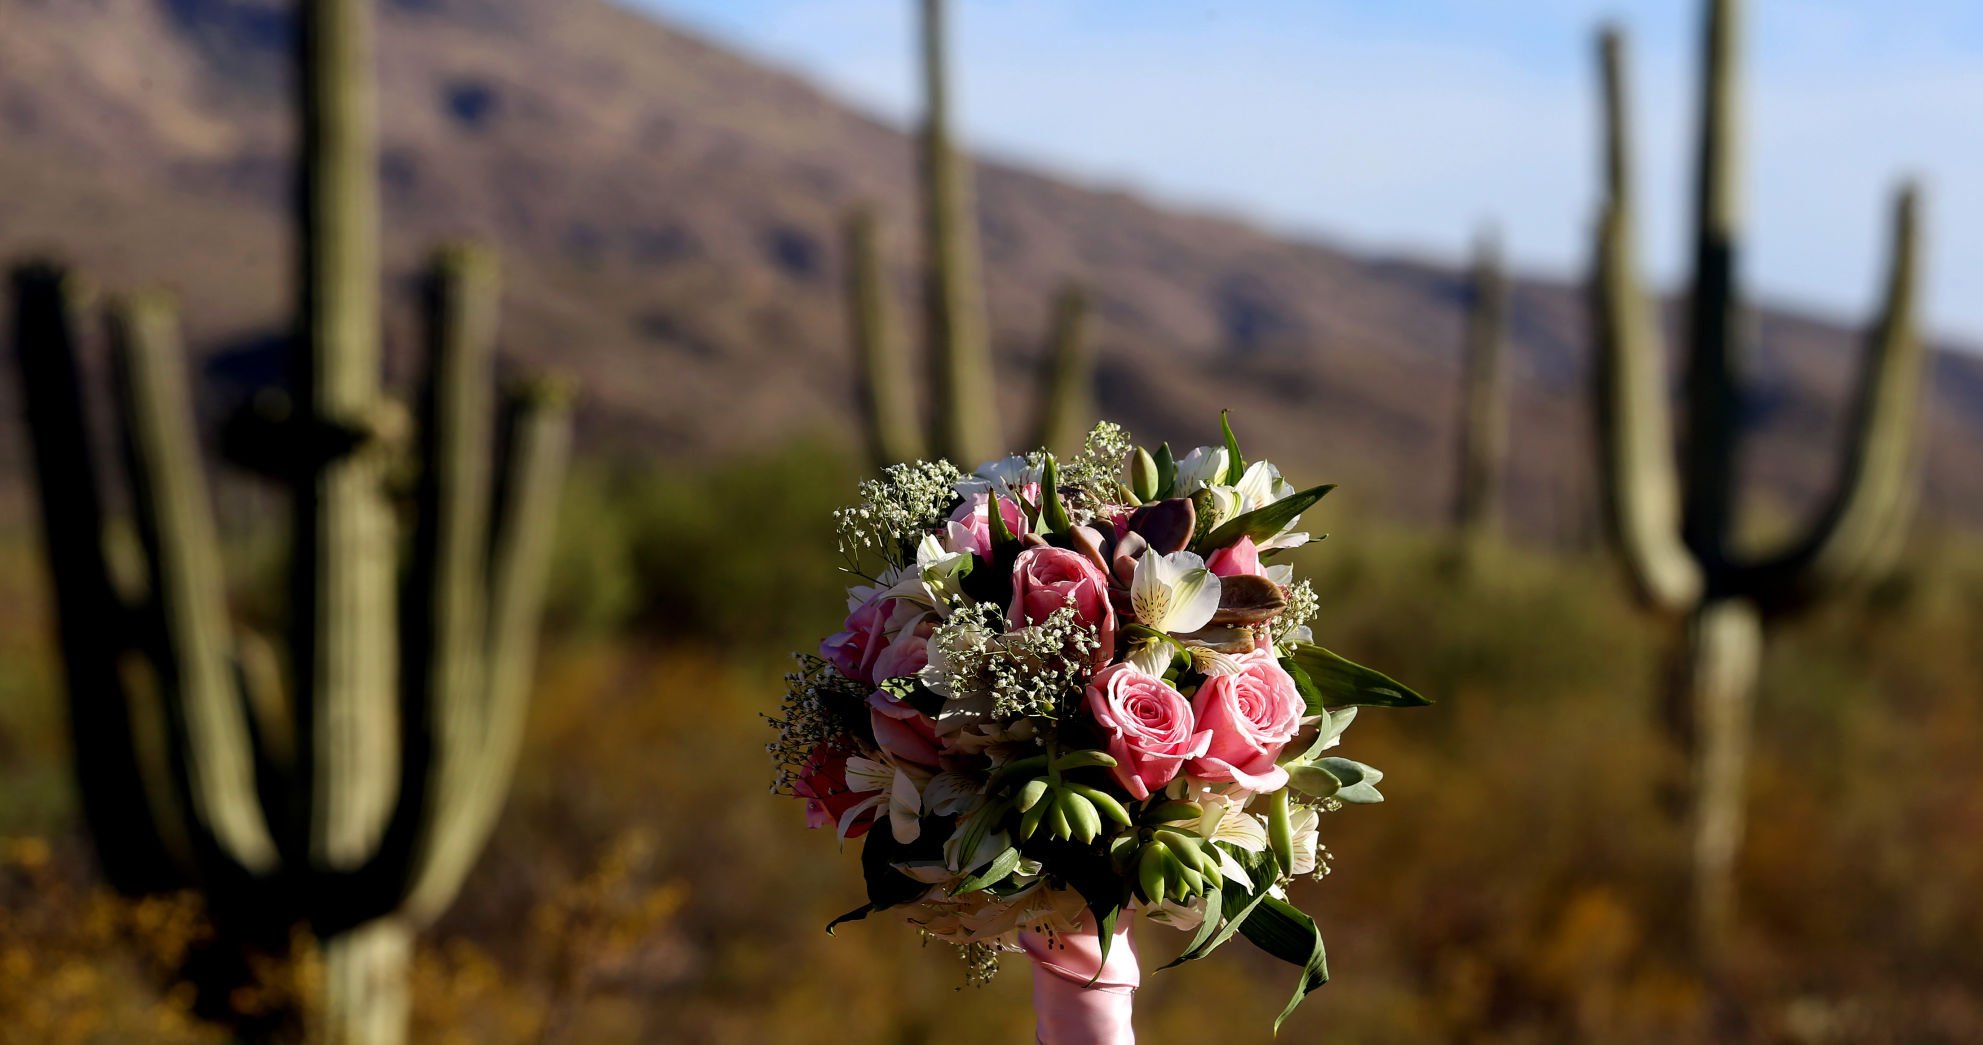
[627,0,1983,347]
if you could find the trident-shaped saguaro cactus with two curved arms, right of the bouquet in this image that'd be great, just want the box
[1592,0,1925,968]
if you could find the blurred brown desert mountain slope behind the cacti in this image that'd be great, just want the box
[0,0,1983,535]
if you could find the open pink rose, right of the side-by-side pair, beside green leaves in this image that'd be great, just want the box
[1184,650,1307,793]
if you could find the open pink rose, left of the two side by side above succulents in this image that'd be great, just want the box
[1087,662,1212,801]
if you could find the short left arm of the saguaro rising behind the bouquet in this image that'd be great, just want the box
[847,210,922,468]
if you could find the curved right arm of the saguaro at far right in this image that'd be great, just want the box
[1757,184,1927,605]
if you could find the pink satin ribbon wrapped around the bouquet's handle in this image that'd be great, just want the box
[1019,914,1142,1045]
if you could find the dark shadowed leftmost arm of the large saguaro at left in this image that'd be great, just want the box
[12,264,182,894]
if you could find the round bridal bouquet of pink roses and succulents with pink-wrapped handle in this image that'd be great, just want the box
[769,422,1426,1043]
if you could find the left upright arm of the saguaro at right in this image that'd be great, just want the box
[1592,30,1703,611]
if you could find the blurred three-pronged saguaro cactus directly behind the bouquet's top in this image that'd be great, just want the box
[847,0,1093,464]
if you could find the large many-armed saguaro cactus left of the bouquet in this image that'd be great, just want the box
[14,0,569,1045]
